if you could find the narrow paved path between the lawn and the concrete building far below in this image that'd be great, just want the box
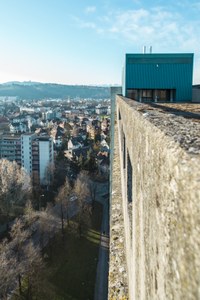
[94,184,109,300]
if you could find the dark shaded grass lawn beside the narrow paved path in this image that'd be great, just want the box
[37,203,102,300]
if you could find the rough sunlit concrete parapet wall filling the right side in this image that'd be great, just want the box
[109,97,200,300]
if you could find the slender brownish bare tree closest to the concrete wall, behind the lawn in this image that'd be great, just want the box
[74,171,91,237]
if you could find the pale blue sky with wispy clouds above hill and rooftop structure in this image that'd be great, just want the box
[0,0,200,84]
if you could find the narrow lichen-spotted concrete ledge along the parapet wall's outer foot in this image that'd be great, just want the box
[108,122,128,300]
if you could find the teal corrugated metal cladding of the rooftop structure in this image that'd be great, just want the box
[123,53,193,101]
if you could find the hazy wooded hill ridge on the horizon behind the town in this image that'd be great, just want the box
[0,81,110,100]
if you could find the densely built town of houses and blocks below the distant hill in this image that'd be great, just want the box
[0,96,110,185]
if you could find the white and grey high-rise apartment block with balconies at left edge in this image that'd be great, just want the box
[0,133,54,185]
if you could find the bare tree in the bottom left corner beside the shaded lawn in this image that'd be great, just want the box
[0,219,43,299]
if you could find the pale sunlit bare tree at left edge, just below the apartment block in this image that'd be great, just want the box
[0,159,31,224]
